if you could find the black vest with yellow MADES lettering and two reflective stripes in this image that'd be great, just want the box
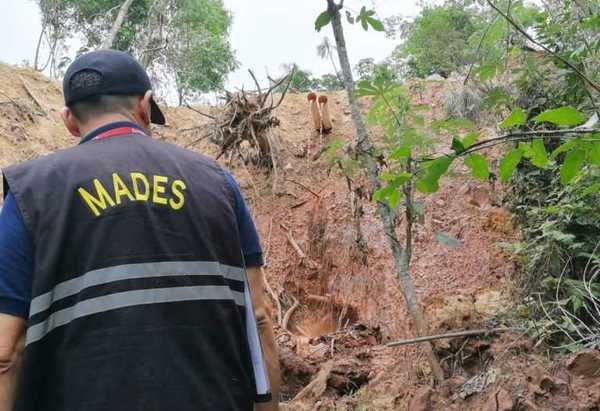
[4,135,256,411]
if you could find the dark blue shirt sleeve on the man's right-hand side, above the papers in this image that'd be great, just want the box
[224,171,263,267]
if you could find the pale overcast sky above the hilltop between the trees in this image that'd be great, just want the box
[0,0,418,96]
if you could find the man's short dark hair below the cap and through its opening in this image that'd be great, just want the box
[69,70,139,122]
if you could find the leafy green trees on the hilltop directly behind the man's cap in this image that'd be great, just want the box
[35,0,237,102]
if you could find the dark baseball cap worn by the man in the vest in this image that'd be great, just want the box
[63,50,165,124]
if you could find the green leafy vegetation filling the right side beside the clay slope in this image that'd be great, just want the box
[315,0,600,356]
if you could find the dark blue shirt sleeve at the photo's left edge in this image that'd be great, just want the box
[0,192,34,318]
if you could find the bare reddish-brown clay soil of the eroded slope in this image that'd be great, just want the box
[0,65,600,411]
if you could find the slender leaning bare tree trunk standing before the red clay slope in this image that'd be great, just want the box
[327,0,444,382]
